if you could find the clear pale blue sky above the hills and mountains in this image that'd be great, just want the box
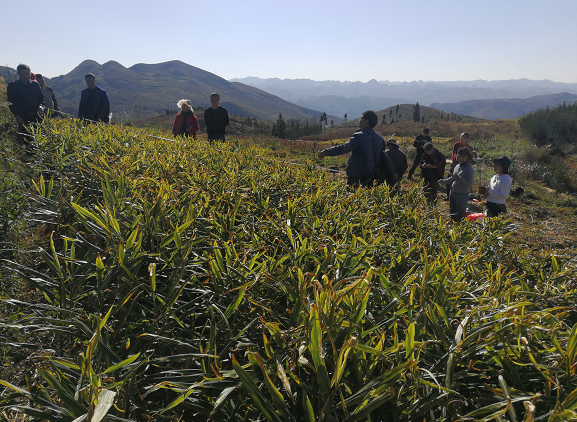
[0,0,577,83]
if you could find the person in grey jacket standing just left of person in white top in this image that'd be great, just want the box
[439,147,475,221]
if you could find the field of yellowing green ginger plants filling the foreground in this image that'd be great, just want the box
[0,116,577,422]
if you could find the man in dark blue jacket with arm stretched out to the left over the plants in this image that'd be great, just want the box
[319,110,385,187]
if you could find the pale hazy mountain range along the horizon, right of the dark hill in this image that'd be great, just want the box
[231,77,577,119]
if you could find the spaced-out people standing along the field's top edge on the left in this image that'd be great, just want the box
[6,64,229,141]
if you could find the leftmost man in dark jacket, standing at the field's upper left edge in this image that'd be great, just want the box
[6,64,44,132]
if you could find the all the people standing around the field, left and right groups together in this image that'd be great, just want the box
[7,64,512,221]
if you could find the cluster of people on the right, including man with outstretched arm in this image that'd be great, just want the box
[318,110,512,221]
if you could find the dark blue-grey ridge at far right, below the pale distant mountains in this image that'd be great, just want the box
[431,92,577,120]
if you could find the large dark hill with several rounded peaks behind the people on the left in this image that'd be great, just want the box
[0,60,328,121]
